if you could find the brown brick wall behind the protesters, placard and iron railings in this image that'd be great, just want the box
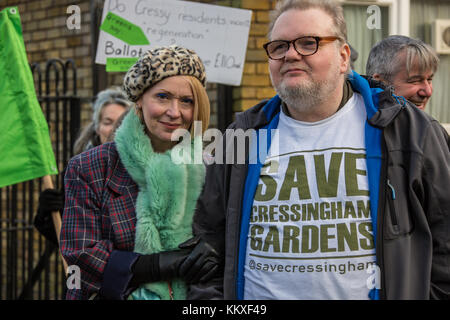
[0,0,275,299]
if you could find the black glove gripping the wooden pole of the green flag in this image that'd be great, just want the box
[33,189,64,246]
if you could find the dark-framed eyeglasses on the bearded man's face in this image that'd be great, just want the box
[263,36,341,60]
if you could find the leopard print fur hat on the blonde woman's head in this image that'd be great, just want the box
[123,46,206,102]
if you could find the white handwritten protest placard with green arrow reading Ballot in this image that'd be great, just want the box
[95,0,252,86]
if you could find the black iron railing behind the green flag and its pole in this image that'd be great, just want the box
[0,59,81,300]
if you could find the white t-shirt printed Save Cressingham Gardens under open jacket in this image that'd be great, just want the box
[244,93,375,299]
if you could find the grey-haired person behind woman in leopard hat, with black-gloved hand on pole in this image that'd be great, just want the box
[33,87,131,246]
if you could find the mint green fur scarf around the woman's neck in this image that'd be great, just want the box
[114,111,205,300]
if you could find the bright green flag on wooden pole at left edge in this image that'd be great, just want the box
[0,7,58,188]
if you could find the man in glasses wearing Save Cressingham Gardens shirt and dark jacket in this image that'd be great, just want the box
[188,0,450,300]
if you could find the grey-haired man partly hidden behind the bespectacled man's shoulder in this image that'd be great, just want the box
[366,35,439,110]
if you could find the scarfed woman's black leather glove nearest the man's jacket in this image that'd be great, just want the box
[178,236,221,283]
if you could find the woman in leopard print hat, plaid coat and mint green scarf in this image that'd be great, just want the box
[61,46,220,300]
